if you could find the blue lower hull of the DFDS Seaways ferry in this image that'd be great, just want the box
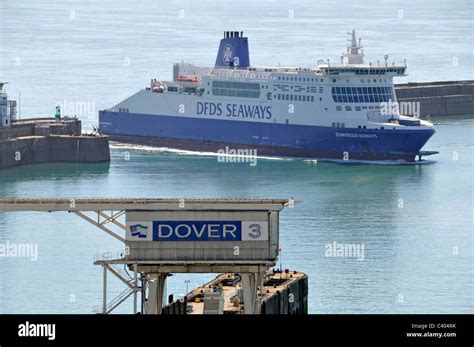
[99,111,435,161]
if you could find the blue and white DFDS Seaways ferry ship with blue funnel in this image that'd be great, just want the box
[99,31,436,162]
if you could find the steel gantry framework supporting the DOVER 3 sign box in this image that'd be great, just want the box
[0,198,294,314]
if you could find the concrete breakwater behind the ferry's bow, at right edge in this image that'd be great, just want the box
[395,81,474,116]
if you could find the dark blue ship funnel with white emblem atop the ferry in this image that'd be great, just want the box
[215,31,250,69]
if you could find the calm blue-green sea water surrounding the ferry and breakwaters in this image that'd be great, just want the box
[0,0,474,313]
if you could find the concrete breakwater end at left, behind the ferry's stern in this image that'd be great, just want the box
[0,118,110,169]
